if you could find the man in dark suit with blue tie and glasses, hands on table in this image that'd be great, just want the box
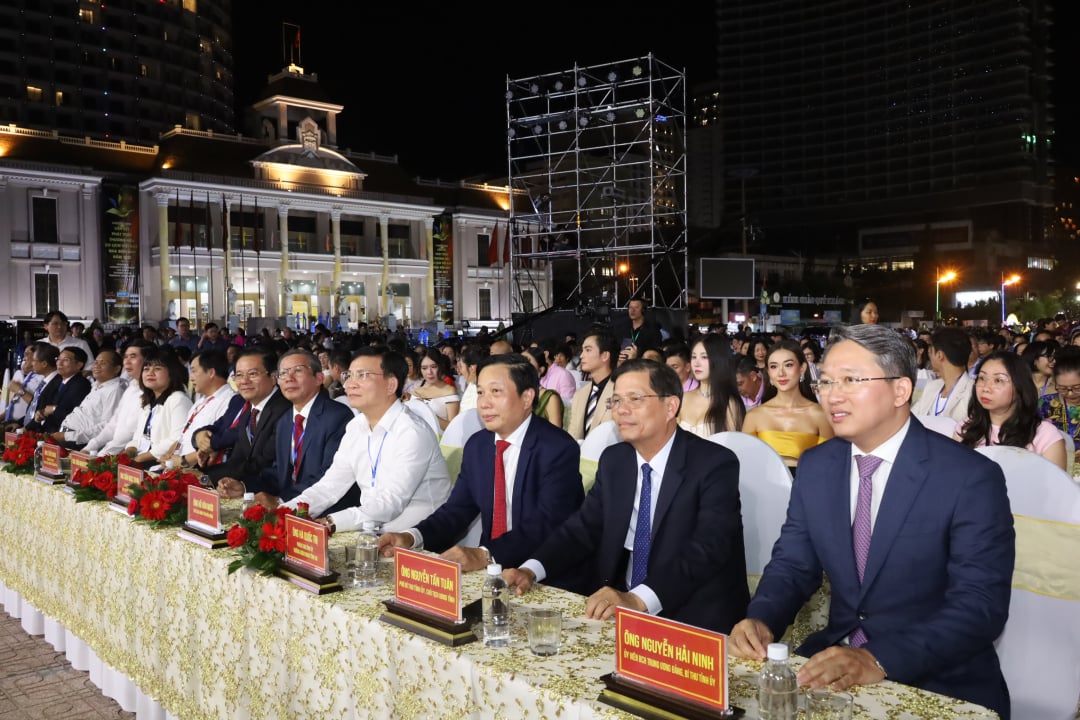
[504,359,750,633]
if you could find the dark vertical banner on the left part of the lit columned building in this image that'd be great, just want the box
[102,184,139,325]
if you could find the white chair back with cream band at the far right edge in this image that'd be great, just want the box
[976,445,1080,720]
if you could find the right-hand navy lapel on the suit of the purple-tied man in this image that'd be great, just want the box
[852,425,929,594]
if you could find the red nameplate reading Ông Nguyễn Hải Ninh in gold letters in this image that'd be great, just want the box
[615,608,728,710]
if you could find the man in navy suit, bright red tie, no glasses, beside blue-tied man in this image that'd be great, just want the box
[379,353,584,571]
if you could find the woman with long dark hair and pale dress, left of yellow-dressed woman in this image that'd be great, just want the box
[678,335,746,437]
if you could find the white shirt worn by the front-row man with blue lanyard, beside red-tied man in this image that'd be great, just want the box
[285,400,450,532]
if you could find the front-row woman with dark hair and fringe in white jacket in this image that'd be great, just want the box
[124,348,191,467]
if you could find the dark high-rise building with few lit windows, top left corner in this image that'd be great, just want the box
[0,0,235,144]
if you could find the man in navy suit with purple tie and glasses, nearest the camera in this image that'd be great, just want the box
[730,325,1015,719]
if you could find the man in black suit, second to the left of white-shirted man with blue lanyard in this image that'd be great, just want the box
[206,349,293,483]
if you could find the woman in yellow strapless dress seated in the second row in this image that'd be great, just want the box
[743,340,833,467]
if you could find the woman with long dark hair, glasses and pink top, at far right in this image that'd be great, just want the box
[955,350,1066,470]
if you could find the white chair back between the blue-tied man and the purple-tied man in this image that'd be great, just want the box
[708,431,792,578]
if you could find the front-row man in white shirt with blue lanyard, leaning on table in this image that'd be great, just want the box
[286,347,450,531]
